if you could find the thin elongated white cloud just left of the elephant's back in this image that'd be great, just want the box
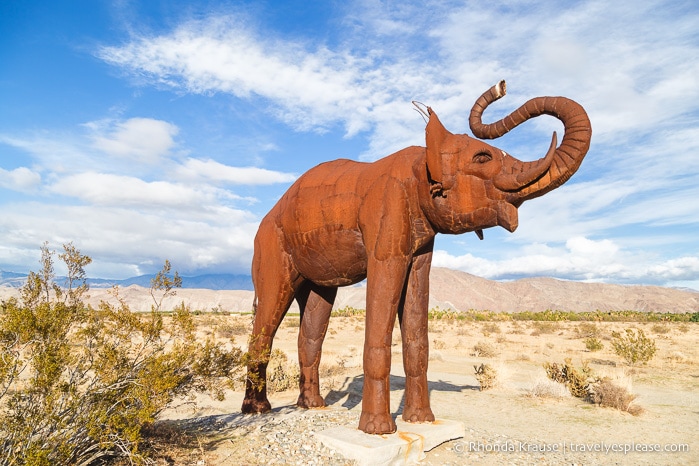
[175,158,296,185]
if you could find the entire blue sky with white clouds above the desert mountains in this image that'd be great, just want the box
[0,0,699,289]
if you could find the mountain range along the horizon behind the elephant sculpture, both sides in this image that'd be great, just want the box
[0,267,699,313]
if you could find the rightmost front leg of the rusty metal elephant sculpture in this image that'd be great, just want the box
[400,243,434,422]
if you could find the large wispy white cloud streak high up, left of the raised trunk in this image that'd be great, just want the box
[100,16,378,135]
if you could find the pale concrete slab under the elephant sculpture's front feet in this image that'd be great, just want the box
[315,419,465,466]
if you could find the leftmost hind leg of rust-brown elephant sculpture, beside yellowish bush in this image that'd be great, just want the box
[241,240,302,413]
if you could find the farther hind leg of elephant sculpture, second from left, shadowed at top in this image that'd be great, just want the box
[296,283,337,408]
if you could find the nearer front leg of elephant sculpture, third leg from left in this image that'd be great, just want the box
[359,257,408,434]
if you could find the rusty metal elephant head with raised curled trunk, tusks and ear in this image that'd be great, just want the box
[423,81,592,239]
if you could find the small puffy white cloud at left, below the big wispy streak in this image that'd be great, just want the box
[86,118,179,163]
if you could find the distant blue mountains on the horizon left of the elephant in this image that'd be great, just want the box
[0,271,253,291]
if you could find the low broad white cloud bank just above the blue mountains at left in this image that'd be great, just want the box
[0,202,257,278]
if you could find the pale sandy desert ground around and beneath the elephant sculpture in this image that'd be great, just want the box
[160,313,699,465]
